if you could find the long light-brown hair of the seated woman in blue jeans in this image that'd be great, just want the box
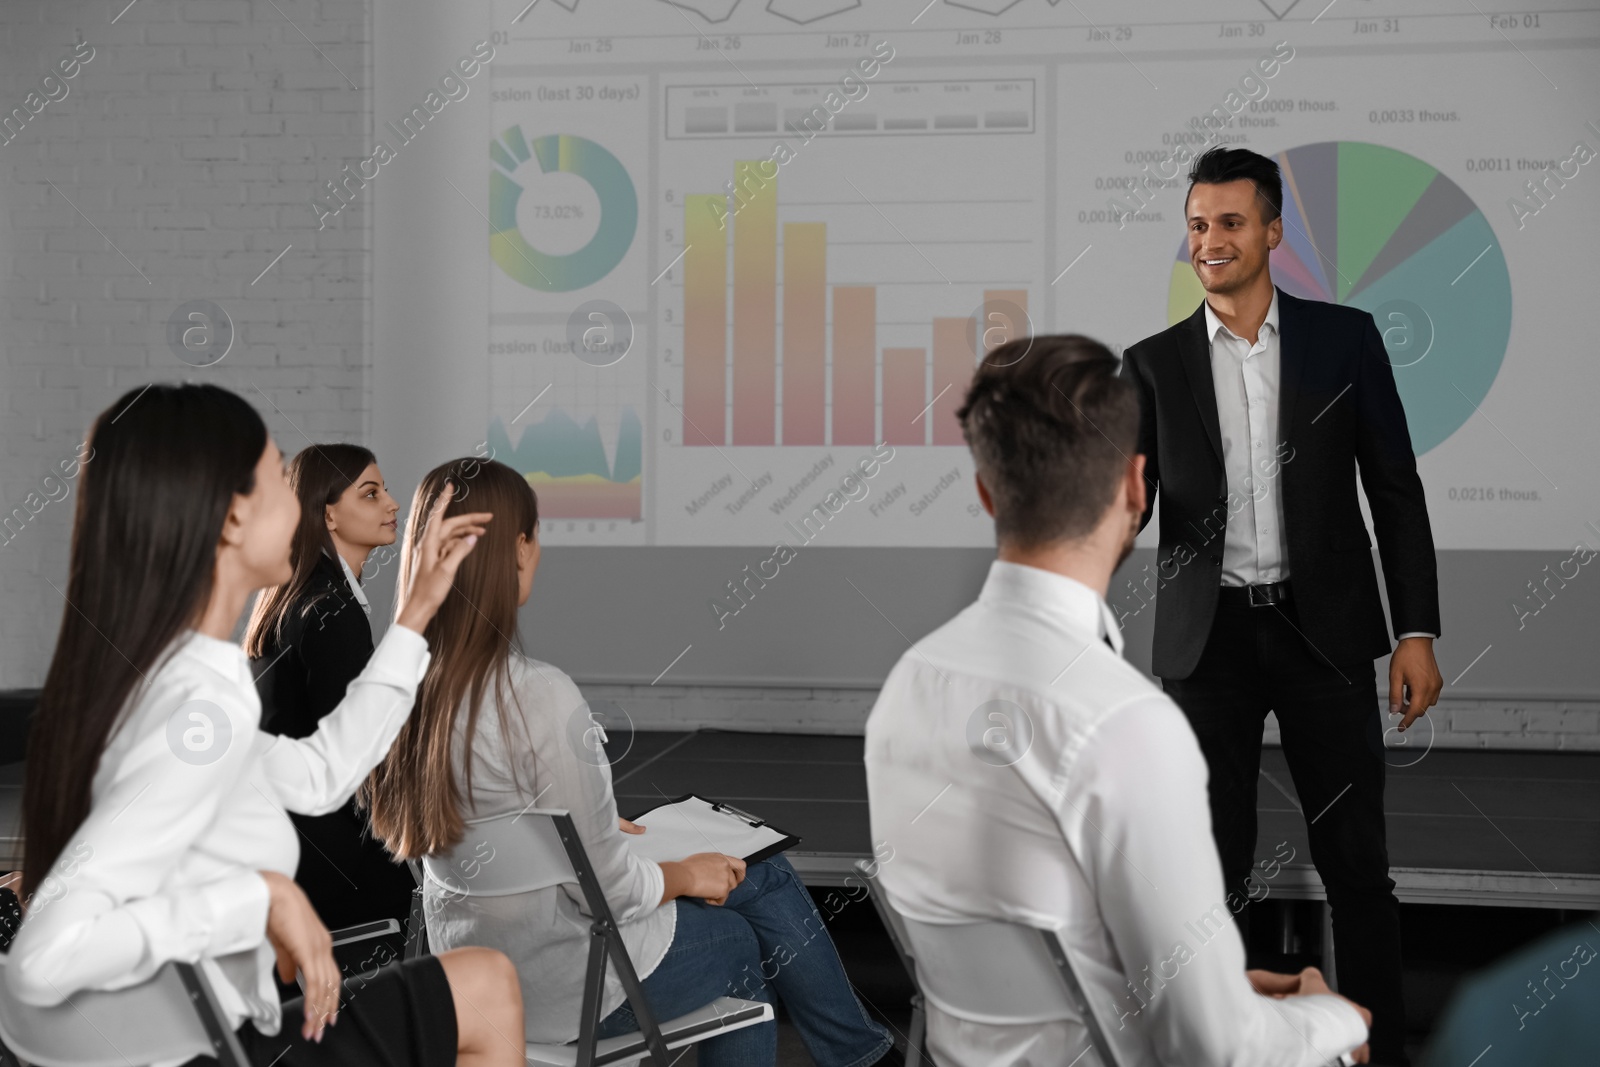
[360,458,539,859]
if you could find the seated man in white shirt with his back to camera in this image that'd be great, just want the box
[866,336,1370,1067]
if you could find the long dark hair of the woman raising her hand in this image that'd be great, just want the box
[22,386,267,899]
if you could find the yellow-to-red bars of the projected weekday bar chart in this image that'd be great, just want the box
[682,160,1027,446]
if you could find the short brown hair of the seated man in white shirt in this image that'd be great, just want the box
[955,334,1139,547]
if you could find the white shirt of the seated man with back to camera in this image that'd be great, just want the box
[866,560,1366,1067]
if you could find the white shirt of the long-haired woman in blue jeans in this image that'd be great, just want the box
[422,653,678,1045]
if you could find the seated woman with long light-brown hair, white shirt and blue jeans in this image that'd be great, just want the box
[363,459,899,1067]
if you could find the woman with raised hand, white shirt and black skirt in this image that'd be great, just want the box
[5,386,523,1067]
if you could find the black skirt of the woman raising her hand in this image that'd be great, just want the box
[184,957,456,1067]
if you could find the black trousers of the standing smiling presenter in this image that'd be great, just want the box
[1162,600,1406,1064]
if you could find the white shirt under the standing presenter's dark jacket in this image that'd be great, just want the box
[1205,286,1437,638]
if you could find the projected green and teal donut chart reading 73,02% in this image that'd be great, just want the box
[490,126,638,293]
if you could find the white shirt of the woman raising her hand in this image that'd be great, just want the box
[5,625,429,1055]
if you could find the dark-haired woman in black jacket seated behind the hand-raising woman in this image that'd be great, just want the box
[245,445,414,929]
